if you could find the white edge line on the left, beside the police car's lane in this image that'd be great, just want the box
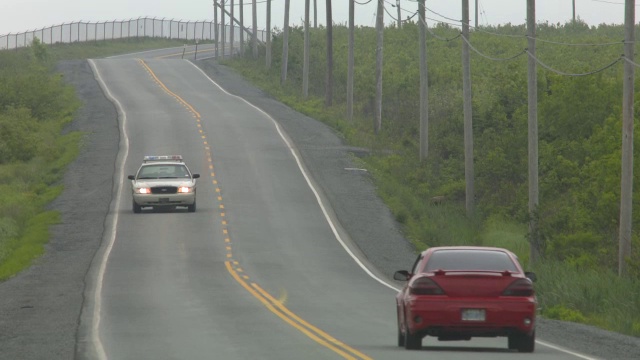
[88,59,129,360]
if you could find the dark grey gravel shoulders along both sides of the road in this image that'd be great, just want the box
[0,60,640,360]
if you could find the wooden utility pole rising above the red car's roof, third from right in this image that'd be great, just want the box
[462,0,475,219]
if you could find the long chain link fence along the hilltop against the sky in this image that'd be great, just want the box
[0,17,267,50]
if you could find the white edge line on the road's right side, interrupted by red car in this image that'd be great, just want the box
[184,60,598,360]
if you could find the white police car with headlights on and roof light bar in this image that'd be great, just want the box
[128,155,200,213]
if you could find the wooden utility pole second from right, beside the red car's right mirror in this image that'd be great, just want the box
[527,0,542,264]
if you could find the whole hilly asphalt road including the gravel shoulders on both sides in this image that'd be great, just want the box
[0,49,640,359]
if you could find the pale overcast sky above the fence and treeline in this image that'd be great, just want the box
[0,0,640,35]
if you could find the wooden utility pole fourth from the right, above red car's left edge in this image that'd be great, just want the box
[418,0,429,161]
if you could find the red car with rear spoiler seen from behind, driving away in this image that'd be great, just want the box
[394,246,537,352]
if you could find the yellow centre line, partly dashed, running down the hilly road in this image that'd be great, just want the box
[138,59,371,360]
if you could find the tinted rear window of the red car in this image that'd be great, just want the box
[425,250,519,272]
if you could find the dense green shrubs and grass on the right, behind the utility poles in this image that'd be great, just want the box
[225,21,640,336]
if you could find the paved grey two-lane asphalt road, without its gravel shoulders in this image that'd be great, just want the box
[70,50,600,359]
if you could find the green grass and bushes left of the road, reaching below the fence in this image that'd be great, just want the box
[0,38,198,280]
